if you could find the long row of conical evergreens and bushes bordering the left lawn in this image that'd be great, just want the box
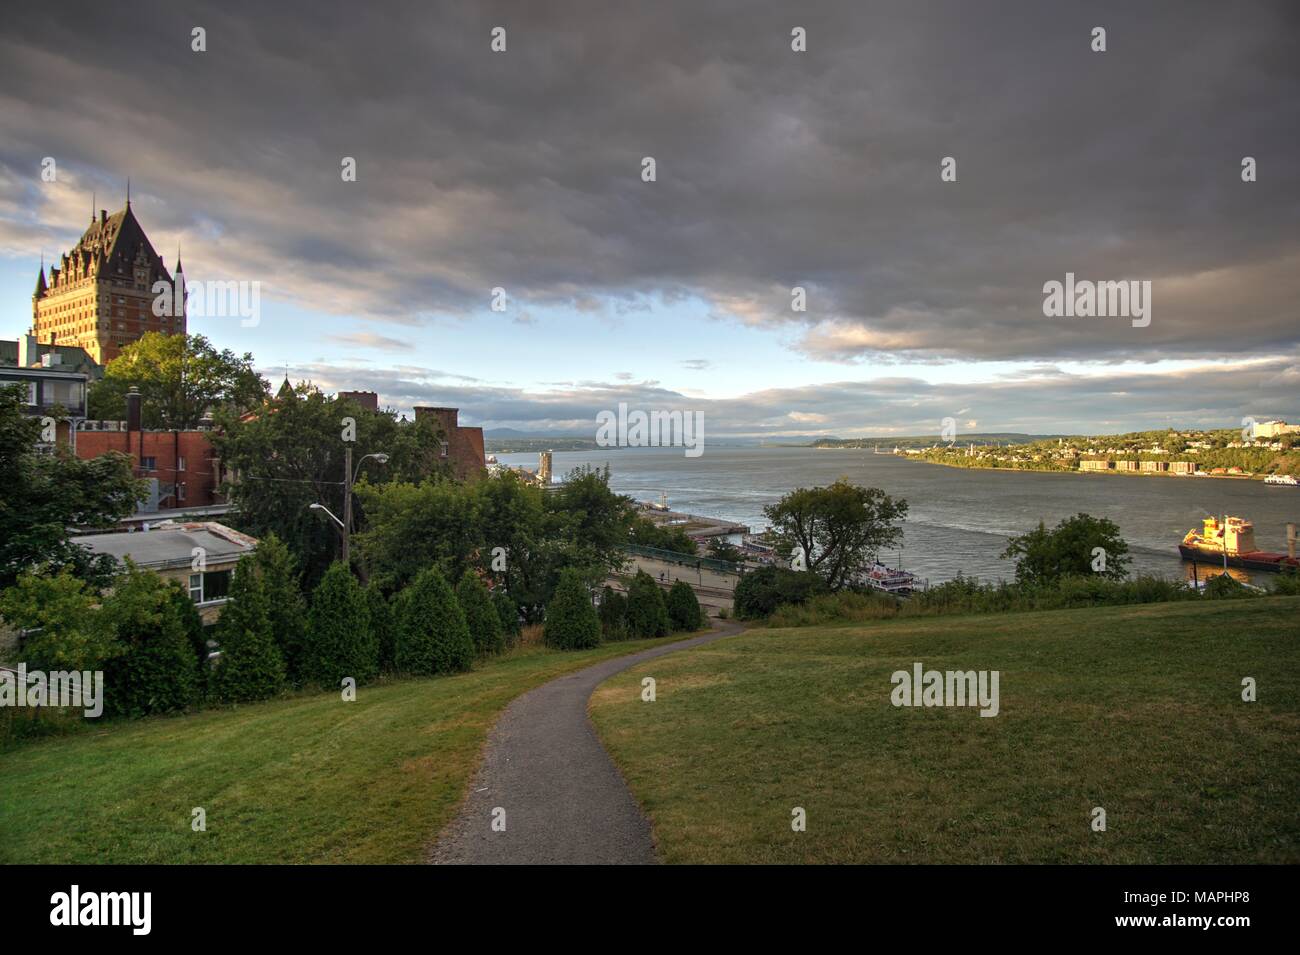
[0,535,520,716]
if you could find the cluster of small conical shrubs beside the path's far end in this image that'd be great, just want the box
[542,570,705,650]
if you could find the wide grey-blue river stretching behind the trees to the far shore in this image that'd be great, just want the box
[498,446,1300,583]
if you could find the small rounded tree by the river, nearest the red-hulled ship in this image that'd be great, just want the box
[1002,513,1130,586]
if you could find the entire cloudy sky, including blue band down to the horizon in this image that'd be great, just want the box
[0,0,1300,438]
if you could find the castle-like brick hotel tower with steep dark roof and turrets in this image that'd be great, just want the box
[31,199,186,365]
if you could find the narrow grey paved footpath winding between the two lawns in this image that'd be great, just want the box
[429,620,745,865]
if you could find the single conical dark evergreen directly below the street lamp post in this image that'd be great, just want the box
[303,561,380,687]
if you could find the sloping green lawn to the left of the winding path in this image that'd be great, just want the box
[0,637,681,863]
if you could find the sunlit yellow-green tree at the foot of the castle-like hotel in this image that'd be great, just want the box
[87,331,269,431]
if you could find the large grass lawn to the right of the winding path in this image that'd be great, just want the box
[592,598,1300,863]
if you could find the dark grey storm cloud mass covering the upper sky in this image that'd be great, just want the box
[0,1,1300,361]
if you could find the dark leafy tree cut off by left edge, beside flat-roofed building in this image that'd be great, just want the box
[0,386,146,589]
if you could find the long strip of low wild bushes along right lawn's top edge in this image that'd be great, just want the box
[736,568,1300,626]
